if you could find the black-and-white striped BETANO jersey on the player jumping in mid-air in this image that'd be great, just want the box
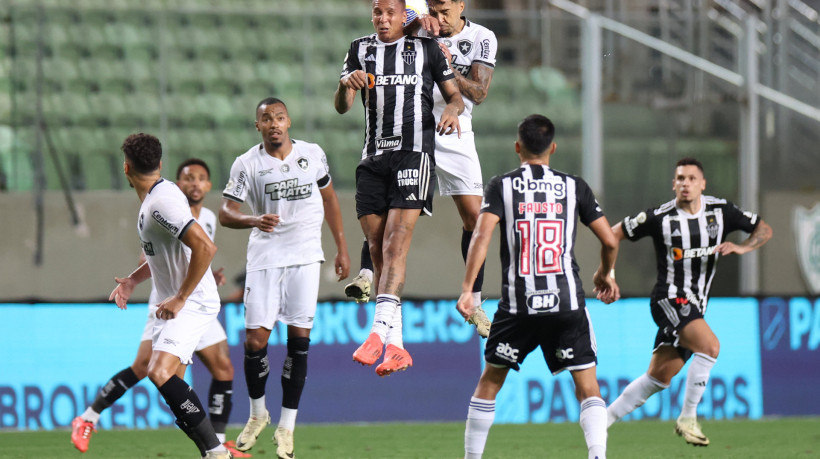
[341,33,455,159]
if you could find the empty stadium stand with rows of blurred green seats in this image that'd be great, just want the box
[0,0,764,209]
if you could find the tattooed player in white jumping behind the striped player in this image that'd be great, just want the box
[345,0,498,337]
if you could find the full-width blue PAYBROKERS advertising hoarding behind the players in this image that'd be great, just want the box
[0,298,820,429]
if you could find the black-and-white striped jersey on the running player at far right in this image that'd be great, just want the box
[623,196,760,311]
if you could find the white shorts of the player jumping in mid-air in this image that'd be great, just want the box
[435,131,484,196]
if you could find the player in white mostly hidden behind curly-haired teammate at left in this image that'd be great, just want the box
[71,158,244,457]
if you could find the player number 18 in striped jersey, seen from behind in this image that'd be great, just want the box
[457,115,620,459]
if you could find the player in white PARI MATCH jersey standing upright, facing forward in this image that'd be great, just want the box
[219,98,350,458]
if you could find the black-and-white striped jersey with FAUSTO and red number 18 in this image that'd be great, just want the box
[481,164,604,315]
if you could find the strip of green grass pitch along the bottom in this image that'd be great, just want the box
[0,418,820,459]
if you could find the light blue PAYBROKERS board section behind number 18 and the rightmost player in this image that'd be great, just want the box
[485,298,763,423]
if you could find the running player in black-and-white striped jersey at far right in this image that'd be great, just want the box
[607,158,772,446]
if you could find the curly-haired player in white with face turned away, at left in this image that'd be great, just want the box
[81,134,233,458]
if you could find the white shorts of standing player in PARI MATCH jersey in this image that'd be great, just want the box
[245,262,321,330]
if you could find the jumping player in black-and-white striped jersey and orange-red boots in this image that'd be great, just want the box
[334,0,464,376]
